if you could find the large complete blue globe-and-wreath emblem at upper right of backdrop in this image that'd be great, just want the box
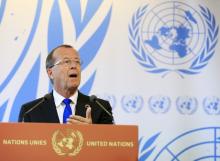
[129,1,219,77]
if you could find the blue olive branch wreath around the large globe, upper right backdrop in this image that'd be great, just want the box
[129,5,219,78]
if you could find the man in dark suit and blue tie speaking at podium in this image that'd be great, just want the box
[18,45,113,124]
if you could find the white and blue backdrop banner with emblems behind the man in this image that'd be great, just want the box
[0,0,220,161]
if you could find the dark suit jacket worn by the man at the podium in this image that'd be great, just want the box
[18,92,113,124]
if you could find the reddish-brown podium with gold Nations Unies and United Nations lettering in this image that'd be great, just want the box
[0,123,138,161]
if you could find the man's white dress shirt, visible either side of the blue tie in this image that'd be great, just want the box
[53,89,78,123]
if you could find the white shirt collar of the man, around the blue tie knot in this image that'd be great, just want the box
[53,89,78,107]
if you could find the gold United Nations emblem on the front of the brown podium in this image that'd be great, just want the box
[52,129,83,156]
